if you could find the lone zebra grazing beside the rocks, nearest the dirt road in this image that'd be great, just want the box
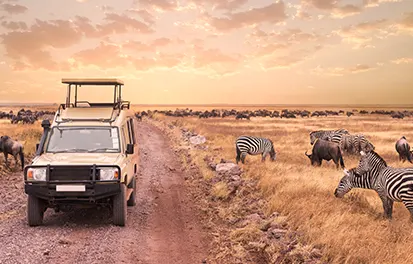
[235,136,276,164]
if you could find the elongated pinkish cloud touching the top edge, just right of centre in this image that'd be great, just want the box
[205,1,287,31]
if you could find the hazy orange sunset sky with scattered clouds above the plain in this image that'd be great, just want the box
[0,0,413,104]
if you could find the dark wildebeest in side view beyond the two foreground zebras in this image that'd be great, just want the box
[305,139,344,169]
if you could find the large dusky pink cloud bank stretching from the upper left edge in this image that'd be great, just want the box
[0,13,153,70]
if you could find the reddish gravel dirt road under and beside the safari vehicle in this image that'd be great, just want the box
[0,123,208,264]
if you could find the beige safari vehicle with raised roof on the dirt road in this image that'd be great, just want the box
[24,79,138,226]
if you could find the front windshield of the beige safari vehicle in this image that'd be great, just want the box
[46,127,120,153]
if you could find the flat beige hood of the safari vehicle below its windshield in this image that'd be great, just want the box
[33,153,122,165]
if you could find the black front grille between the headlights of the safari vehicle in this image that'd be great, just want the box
[49,166,99,181]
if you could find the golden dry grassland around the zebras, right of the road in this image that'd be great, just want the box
[146,110,413,263]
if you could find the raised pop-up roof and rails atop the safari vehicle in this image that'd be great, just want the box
[55,78,130,124]
